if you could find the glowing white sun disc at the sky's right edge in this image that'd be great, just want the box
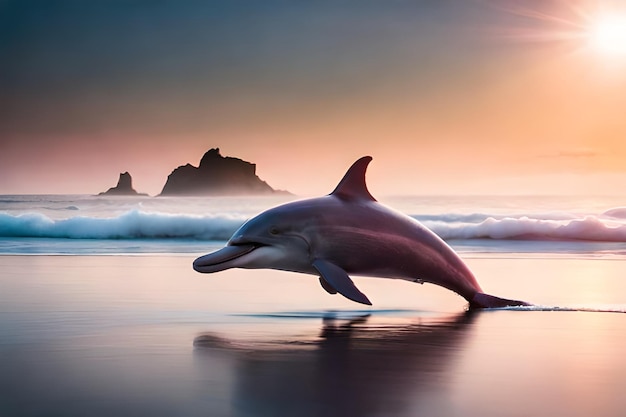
[588,14,626,57]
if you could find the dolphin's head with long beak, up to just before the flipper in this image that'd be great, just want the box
[193,203,311,273]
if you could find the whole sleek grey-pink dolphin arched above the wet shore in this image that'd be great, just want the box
[193,156,530,309]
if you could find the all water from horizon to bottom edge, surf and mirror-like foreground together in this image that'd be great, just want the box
[0,196,626,417]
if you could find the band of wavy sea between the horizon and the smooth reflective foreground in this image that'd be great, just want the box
[0,195,626,257]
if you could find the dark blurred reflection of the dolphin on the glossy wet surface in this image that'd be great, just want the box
[194,312,475,417]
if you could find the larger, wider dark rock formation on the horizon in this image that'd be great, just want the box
[160,148,286,196]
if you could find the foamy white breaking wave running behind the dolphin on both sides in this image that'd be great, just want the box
[0,209,626,242]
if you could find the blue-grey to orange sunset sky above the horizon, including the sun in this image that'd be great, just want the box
[0,0,626,196]
